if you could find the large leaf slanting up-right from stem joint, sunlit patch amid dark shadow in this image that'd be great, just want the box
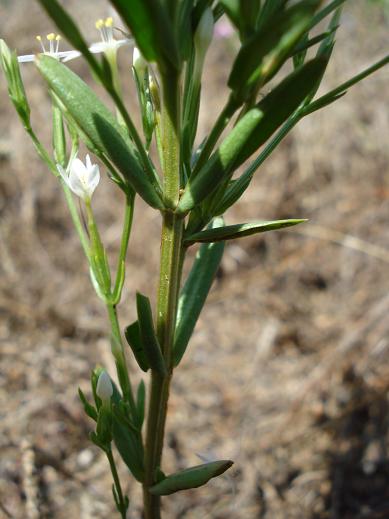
[176,58,327,214]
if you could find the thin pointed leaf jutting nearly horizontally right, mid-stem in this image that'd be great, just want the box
[184,219,307,245]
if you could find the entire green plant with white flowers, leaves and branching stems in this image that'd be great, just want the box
[0,0,389,519]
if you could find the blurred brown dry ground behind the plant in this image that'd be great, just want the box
[0,0,389,519]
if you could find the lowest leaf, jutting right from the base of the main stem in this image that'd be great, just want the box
[149,460,234,496]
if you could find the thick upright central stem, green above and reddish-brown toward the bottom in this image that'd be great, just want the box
[143,70,184,519]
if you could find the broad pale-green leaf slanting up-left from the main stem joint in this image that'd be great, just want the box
[37,55,163,209]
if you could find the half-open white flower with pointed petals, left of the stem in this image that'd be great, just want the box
[57,155,100,201]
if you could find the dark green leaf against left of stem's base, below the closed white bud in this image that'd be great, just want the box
[112,413,144,482]
